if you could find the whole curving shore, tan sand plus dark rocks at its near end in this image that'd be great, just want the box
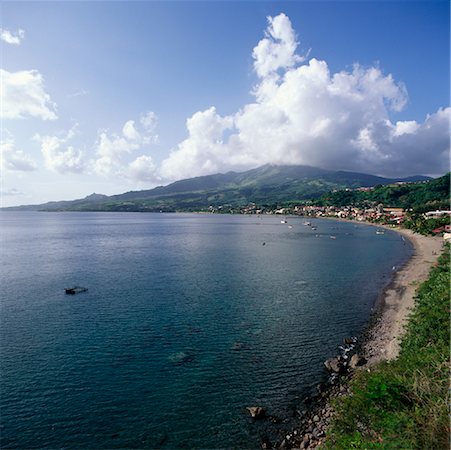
[261,226,443,449]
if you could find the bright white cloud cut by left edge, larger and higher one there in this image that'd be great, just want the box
[0,69,57,120]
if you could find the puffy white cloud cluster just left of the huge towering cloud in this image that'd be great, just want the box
[92,111,158,181]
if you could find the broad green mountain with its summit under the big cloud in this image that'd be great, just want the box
[3,164,430,211]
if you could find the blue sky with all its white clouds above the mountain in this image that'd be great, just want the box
[0,0,451,206]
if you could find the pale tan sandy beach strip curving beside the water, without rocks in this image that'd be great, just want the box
[363,227,443,365]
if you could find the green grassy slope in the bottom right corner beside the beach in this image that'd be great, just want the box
[325,246,450,450]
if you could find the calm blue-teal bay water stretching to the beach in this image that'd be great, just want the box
[0,211,412,449]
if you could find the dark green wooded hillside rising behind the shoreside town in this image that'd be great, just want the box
[318,173,450,213]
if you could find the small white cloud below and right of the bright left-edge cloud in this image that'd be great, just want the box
[35,125,85,173]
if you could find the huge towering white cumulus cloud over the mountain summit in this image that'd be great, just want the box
[160,14,451,180]
